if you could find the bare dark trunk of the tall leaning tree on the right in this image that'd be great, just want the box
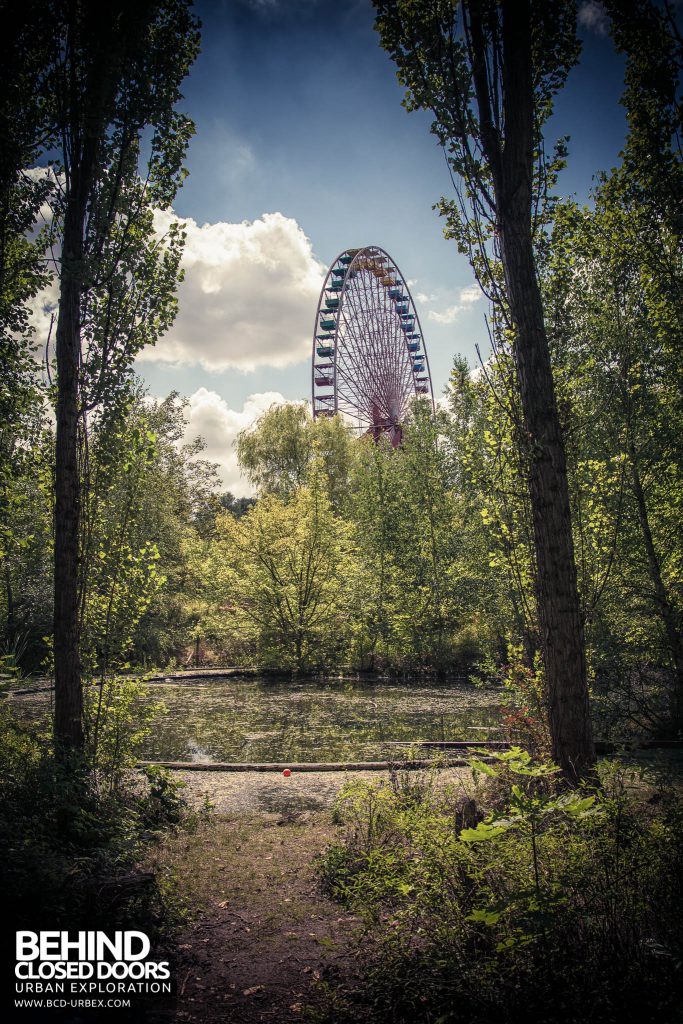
[495,0,595,779]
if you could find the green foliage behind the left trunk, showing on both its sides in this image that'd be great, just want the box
[0,385,220,678]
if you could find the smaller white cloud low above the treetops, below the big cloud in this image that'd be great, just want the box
[184,387,294,496]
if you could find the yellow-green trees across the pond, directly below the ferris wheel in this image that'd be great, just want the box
[211,401,507,673]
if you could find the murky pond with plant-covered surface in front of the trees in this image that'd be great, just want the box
[9,676,500,762]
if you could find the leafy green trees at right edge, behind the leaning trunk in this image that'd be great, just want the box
[546,190,683,734]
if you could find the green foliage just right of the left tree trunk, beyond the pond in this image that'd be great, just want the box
[83,390,220,674]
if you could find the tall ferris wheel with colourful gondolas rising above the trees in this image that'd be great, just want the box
[311,246,434,447]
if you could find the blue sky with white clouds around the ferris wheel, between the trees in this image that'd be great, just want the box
[127,0,626,495]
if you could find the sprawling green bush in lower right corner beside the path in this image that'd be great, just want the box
[317,750,683,1024]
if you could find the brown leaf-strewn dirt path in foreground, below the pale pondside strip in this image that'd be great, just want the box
[152,813,358,1024]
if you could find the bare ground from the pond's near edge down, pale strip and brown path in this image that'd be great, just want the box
[146,772,413,1024]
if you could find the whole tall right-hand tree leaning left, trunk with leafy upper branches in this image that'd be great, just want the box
[376,0,594,780]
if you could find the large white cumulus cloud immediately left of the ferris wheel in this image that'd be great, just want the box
[139,212,324,372]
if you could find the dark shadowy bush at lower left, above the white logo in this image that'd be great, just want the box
[0,708,185,950]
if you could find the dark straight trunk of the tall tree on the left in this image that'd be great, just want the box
[54,0,127,750]
